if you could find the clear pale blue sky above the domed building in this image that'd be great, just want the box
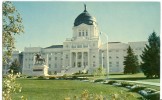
[14,1,160,51]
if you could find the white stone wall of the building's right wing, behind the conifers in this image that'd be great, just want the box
[100,41,147,73]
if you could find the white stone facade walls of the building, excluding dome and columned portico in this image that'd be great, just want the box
[23,41,147,74]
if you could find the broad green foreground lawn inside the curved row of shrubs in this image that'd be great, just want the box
[15,79,141,100]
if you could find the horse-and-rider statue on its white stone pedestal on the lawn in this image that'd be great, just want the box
[33,53,48,76]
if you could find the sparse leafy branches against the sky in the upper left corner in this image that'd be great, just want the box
[2,1,24,64]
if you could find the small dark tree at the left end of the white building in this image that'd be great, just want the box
[9,59,20,74]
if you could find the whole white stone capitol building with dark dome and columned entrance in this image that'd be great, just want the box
[2,6,147,75]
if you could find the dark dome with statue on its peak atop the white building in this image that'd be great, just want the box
[74,5,96,26]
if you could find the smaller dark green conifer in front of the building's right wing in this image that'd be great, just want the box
[123,46,139,74]
